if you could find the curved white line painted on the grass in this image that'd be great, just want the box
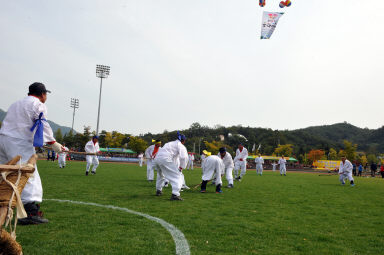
[44,199,191,255]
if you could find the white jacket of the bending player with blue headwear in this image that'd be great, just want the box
[156,140,188,169]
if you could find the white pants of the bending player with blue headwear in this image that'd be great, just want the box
[154,158,183,196]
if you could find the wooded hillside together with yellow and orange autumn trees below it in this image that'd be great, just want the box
[55,123,382,164]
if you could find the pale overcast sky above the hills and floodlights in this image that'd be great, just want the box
[0,0,384,134]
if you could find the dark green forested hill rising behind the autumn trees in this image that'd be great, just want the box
[142,122,384,155]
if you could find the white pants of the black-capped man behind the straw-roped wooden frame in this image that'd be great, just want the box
[0,135,43,204]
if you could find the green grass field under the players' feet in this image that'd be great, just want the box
[17,161,384,255]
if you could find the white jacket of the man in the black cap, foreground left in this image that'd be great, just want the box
[0,96,56,143]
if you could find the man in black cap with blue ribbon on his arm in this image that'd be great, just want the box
[0,82,63,225]
